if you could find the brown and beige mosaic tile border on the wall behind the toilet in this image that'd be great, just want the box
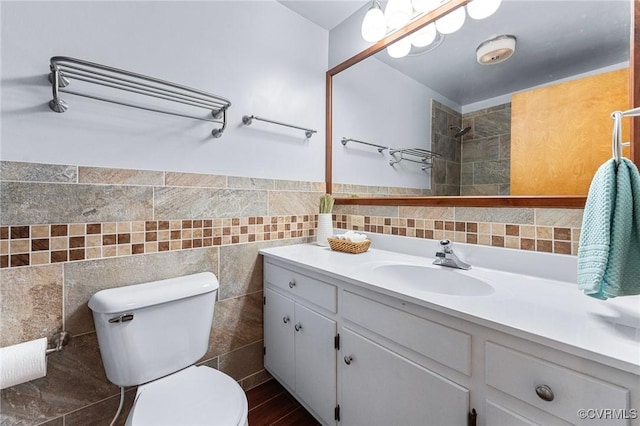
[0,215,318,268]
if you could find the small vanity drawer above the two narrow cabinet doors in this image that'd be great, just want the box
[264,262,338,312]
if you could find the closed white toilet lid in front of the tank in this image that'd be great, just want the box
[127,366,247,426]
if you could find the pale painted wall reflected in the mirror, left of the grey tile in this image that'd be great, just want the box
[332,52,460,189]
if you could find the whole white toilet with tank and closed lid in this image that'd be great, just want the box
[89,272,248,426]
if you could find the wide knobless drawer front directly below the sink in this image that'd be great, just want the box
[342,291,471,376]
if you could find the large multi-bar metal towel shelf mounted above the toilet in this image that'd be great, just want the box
[49,56,231,138]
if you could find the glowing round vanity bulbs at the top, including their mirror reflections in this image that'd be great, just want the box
[361,0,502,58]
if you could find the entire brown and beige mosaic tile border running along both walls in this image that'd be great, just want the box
[0,214,580,268]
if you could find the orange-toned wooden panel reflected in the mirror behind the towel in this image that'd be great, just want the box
[511,69,630,195]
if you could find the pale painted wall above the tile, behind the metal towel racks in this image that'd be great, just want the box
[0,0,328,181]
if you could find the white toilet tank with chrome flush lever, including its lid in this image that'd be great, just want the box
[89,272,218,386]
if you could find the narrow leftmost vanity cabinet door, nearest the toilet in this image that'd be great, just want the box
[264,288,295,389]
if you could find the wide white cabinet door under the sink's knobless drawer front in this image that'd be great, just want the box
[340,328,469,426]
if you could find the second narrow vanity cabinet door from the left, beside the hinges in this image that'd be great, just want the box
[295,304,337,424]
